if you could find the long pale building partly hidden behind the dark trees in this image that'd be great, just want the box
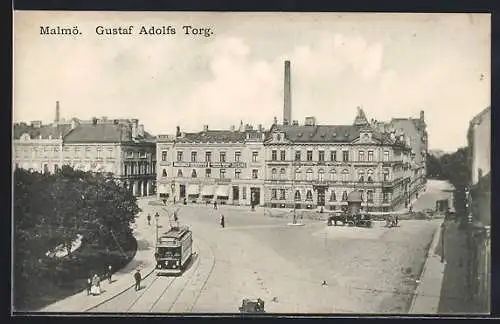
[13,103,156,196]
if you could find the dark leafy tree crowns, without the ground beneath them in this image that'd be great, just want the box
[14,166,140,306]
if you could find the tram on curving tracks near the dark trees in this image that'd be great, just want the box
[155,226,193,275]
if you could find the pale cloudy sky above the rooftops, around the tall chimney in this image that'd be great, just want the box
[13,11,491,151]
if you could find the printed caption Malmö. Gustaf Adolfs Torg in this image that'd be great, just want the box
[40,25,214,37]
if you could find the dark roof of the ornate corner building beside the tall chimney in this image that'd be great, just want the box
[273,125,391,144]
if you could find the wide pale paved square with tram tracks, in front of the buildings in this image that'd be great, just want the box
[87,182,454,313]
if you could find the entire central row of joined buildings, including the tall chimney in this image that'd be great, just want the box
[156,61,427,211]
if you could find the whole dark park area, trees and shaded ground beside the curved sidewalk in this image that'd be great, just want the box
[13,167,139,311]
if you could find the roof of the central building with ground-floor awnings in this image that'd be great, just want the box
[176,130,259,143]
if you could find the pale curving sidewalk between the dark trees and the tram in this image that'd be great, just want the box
[40,198,159,312]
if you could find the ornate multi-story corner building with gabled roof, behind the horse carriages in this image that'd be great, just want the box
[264,108,410,211]
